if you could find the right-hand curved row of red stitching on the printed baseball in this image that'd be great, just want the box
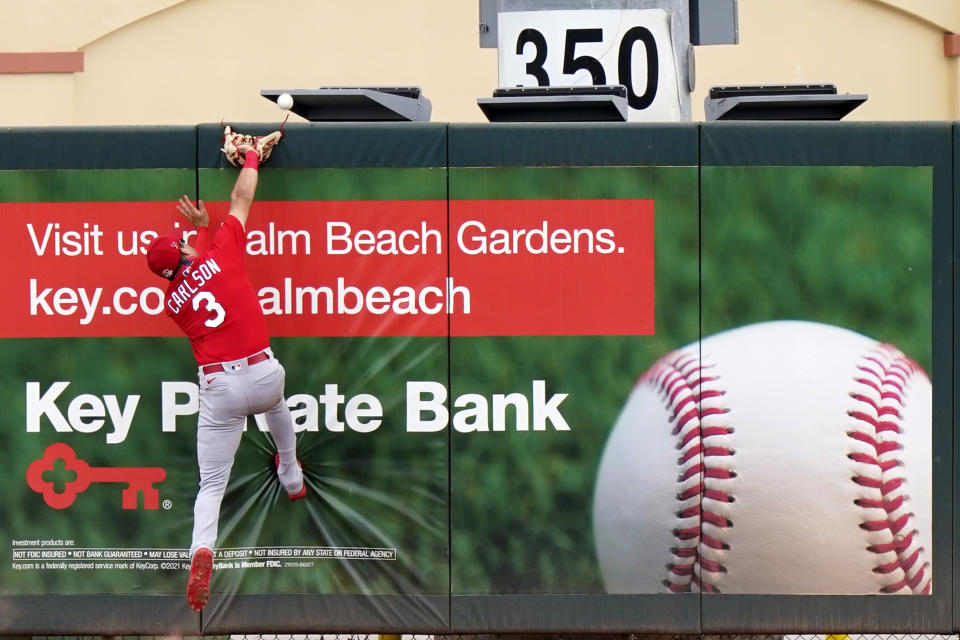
[847,344,932,594]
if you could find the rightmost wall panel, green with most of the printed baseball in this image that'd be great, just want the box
[688,123,953,633]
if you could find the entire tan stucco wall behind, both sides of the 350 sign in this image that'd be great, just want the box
[0,0,960,126]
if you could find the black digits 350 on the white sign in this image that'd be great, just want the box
[517,27,659,109]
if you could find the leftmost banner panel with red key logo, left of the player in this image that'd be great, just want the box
[0,165,196,630]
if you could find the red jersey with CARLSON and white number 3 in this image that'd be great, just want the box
[164,216,270,365]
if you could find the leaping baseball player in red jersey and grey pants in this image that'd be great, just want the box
[147,140,298,611]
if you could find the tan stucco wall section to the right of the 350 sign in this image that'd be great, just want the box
[693,0,960,120]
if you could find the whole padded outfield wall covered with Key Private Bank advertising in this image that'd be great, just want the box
[0,123,960,635]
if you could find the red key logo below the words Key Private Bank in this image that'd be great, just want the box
[27,442,167,509]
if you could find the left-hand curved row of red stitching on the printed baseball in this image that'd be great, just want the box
[640,352,736,593]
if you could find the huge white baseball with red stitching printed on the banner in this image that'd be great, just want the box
[593,321,933,595]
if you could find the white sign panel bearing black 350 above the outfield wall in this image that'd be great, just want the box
[497,9,683,122]
